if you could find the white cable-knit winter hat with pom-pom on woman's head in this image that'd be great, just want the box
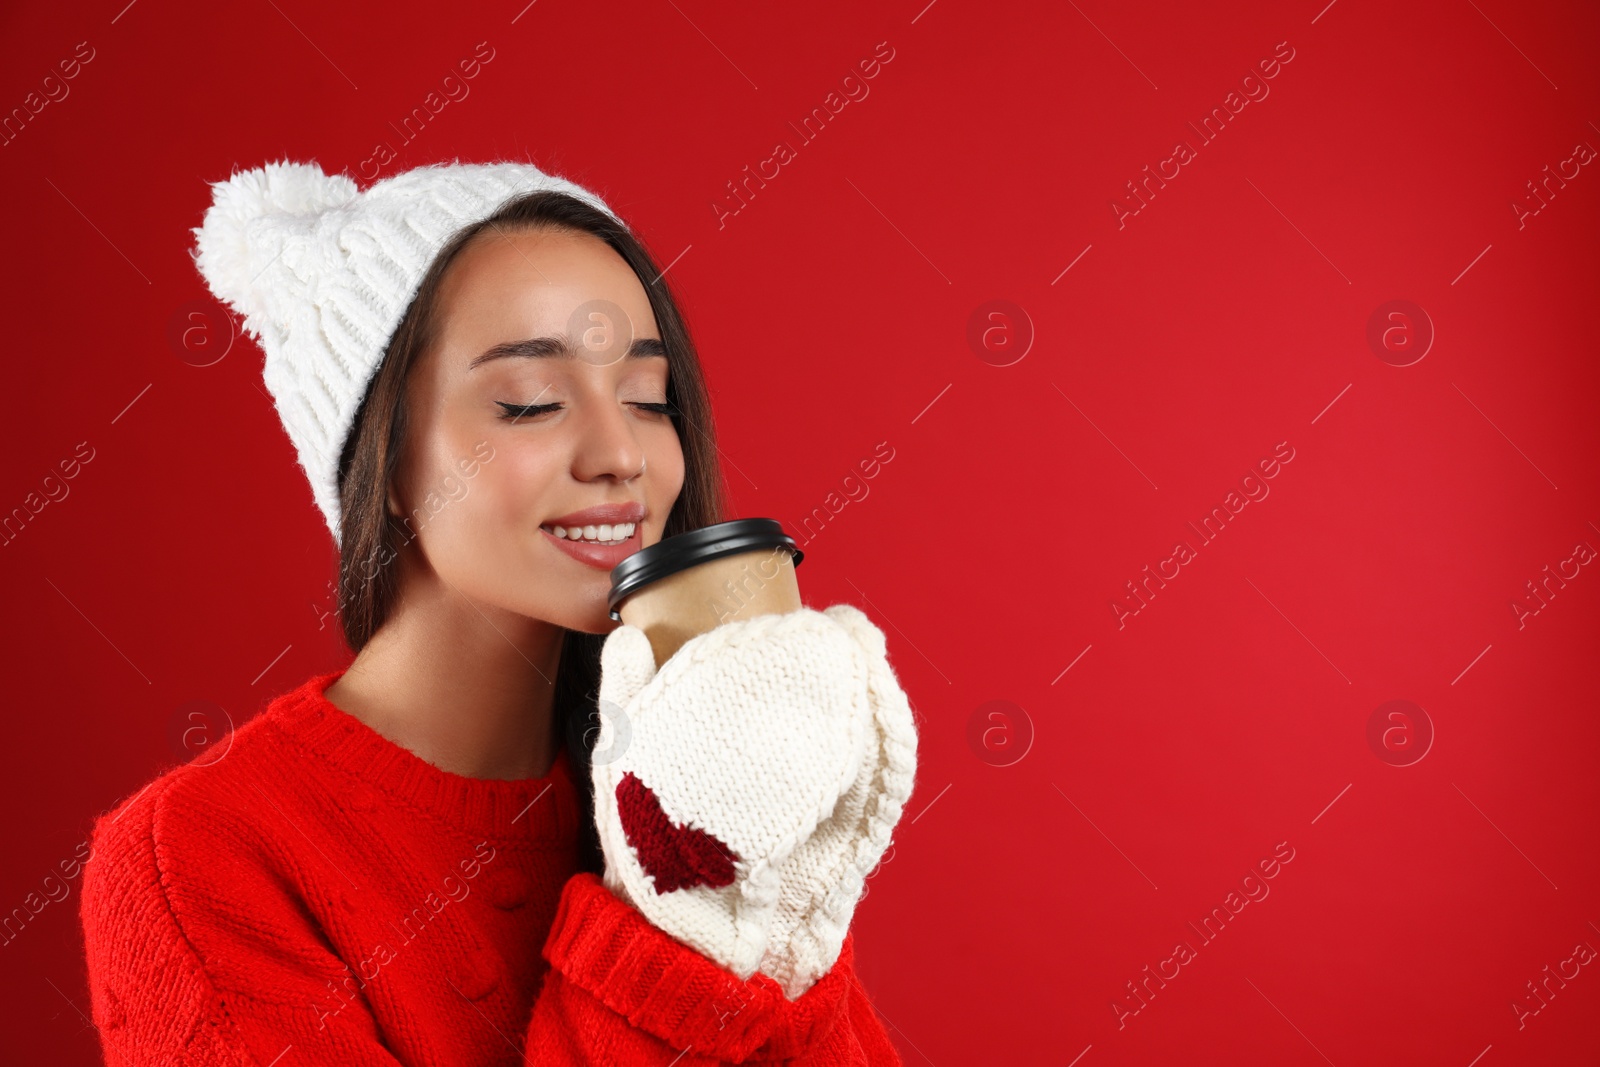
[190,160,621,542]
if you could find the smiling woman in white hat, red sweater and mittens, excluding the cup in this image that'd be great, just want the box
[82,162,915,1067]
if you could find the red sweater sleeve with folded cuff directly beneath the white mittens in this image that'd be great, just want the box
[526,872,901,1067]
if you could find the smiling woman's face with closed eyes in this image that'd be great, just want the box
[389,229,683,633]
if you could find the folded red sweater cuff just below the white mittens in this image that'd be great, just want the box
[544,872,854,1062]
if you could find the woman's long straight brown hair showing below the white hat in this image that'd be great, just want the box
[339,190,725,873]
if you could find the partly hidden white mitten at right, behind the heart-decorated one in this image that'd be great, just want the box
[760,603,917,1000]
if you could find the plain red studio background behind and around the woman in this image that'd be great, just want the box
[0,0,1600,1067]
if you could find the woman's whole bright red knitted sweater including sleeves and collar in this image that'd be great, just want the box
[82,670,901,1067]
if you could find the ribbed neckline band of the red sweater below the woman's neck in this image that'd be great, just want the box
[264,667,578,845]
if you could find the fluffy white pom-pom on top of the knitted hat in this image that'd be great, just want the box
[190,160,360,320]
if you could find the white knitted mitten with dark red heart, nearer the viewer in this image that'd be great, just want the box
[592,608,882,979]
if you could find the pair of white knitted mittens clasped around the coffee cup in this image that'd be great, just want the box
[592,605,917,1000]
